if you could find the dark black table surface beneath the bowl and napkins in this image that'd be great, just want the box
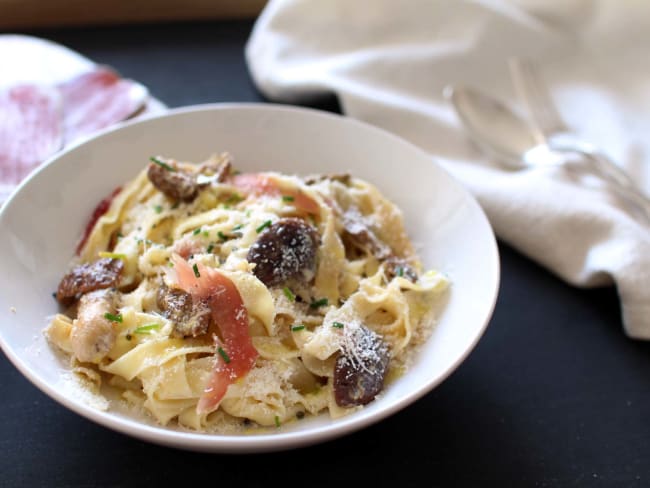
[0,21,650,488]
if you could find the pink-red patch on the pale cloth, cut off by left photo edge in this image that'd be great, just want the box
[0,84,63,202]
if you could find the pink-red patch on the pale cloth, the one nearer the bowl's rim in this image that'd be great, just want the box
[59,66,149,144]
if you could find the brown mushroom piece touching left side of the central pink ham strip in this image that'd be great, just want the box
[156,284,210,337]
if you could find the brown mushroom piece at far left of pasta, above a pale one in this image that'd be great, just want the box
[56,258,124,304]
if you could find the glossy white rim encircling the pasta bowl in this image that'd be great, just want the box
[0,102,501,454]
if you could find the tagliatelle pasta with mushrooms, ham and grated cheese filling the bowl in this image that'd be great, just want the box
[45,154,448,432]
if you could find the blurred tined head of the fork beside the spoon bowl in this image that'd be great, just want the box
[509,58,568,142]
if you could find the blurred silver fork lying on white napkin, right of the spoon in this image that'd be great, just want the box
[509,58,650,223]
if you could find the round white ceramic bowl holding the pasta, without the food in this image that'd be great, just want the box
[0,104,499,452]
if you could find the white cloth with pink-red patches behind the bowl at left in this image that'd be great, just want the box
[0,35,164,203]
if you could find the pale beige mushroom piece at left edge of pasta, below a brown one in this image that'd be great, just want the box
[70,290,117,363]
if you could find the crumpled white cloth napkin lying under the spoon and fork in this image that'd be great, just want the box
[246,0,650,339]
